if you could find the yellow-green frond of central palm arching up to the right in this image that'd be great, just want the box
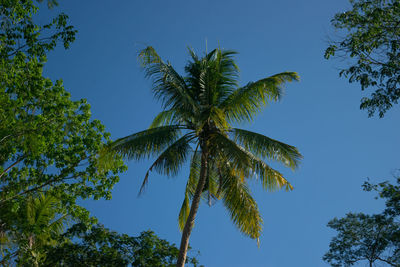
[220,72,299,122]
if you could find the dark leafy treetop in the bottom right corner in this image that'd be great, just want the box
[324,213,400,266]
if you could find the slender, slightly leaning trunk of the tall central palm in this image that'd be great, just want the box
[176,145,208,267]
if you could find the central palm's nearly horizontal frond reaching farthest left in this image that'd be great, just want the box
[106,125,181,160]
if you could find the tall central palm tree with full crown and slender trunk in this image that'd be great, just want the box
[109,47,302,266]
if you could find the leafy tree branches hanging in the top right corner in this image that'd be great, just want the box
[325,0,400,117]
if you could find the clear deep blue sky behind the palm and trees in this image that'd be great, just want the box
[40,0,400,267]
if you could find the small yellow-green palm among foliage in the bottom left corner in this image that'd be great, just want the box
[0,193,68,266]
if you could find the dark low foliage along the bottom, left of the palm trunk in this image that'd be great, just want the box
[43,224,198,267]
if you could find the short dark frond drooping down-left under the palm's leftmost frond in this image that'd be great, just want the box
[139,133,195,194]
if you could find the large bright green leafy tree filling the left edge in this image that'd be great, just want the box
[0,0,126,266]
